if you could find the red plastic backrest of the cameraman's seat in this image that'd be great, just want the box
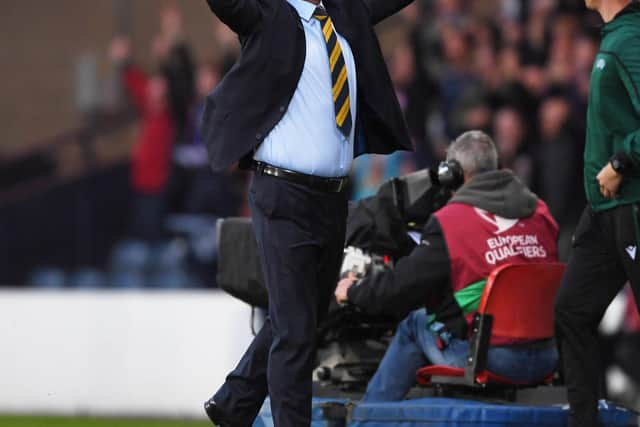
[478,263,565,341]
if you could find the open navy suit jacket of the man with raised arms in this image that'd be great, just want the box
[203,0,412,170]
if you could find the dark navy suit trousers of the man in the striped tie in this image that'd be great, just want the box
[214,174,347,427]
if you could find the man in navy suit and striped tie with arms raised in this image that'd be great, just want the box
[203,0,412,427]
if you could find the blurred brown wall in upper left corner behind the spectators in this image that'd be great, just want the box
[0,0,220,158]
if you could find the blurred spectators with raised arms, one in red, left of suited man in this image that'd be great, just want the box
[109,4,246,241]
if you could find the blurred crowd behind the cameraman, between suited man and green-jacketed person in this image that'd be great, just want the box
[388,0,600,232]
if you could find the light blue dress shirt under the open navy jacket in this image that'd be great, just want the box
[254,0,357,177]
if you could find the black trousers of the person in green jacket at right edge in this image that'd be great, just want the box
[555,205,640,427]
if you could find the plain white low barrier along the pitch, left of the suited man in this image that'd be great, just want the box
[0,290,252,418]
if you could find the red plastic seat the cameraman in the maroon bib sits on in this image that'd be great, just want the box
[416,263,565,388]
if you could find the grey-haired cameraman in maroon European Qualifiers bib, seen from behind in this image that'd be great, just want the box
[335,131,558,401]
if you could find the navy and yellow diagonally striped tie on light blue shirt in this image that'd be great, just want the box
[313,6,351,138]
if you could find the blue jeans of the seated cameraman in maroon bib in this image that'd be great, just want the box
[362,309,558,402]
